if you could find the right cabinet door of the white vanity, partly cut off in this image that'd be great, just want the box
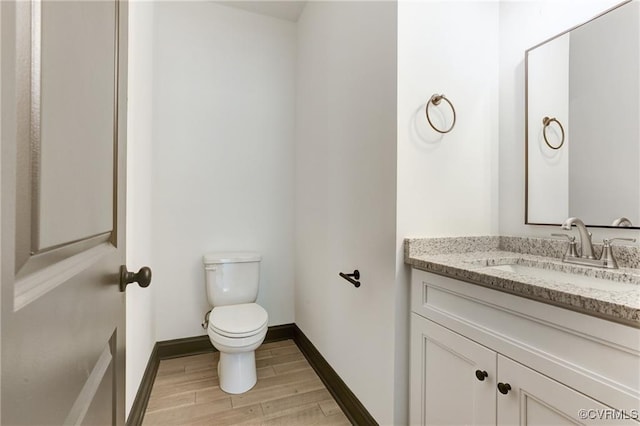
[497,355,638,426]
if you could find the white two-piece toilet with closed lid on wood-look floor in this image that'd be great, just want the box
[202,252,269,394]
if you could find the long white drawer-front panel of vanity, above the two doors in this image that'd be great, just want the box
[411,269,640,409]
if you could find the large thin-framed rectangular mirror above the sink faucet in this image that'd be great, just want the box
[525,0,640,229]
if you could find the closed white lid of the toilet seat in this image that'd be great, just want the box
[209,303,269,337]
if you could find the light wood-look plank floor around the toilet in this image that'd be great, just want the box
[143,340,350,426]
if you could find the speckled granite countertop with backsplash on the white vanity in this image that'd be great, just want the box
[405,237,640,328]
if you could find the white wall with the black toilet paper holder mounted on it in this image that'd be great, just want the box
[295,2,406,424]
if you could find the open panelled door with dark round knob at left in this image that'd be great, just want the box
[0,0,128,425]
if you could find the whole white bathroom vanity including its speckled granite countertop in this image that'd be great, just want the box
[405,237,640,425]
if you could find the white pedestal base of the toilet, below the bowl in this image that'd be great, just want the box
[218,351,258,394]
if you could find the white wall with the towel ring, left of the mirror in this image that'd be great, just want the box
[394,1,499,424]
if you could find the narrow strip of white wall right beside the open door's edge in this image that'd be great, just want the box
[125,1,156,416]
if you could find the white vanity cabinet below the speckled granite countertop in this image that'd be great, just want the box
[410,269,640,425]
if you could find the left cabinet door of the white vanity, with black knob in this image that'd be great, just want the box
[410,314,496,425]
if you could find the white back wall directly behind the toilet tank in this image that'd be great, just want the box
[151,2,296,341]
